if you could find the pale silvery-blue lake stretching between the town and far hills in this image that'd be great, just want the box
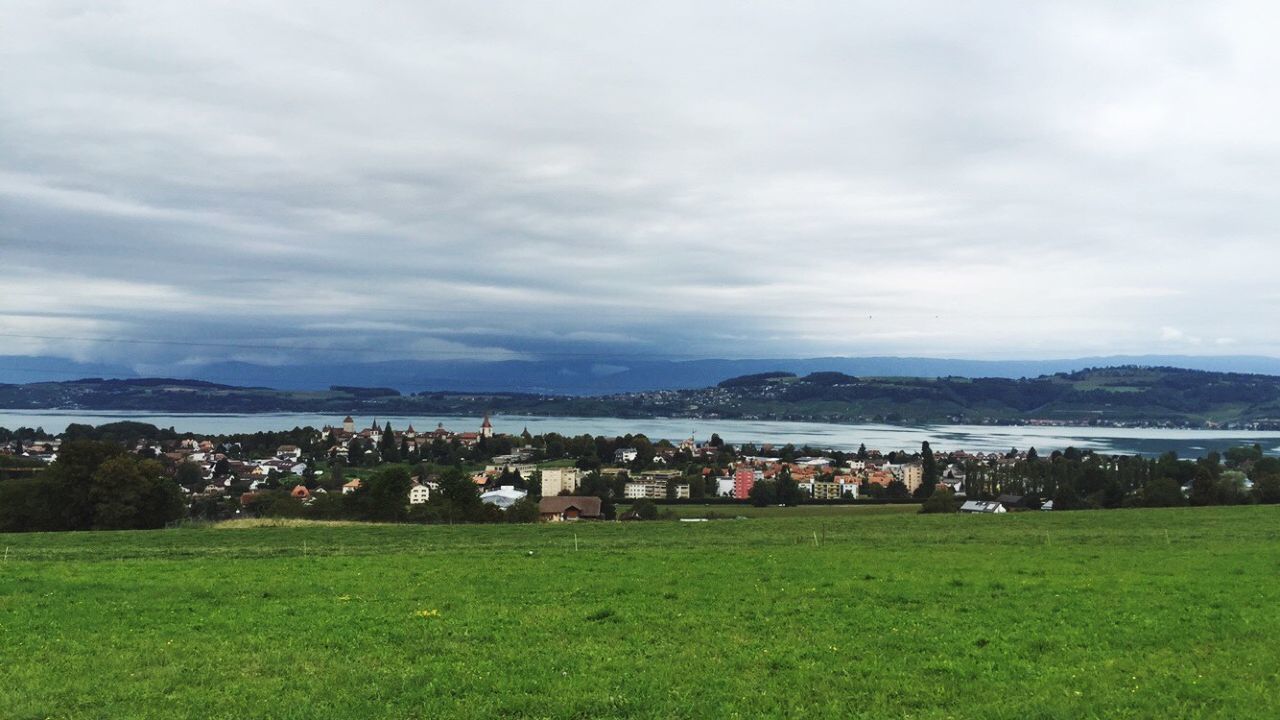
[0,410,1280,457]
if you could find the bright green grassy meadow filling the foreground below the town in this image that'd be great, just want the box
[0,507,1280,720]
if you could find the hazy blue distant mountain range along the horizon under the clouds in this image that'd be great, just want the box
[0,355,1280,396]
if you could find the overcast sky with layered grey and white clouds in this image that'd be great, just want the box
[0,0,1280,365]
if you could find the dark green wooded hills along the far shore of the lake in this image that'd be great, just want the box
[0,366,1280,428]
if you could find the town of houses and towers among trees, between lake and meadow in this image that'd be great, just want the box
[0,415,1280,525]
